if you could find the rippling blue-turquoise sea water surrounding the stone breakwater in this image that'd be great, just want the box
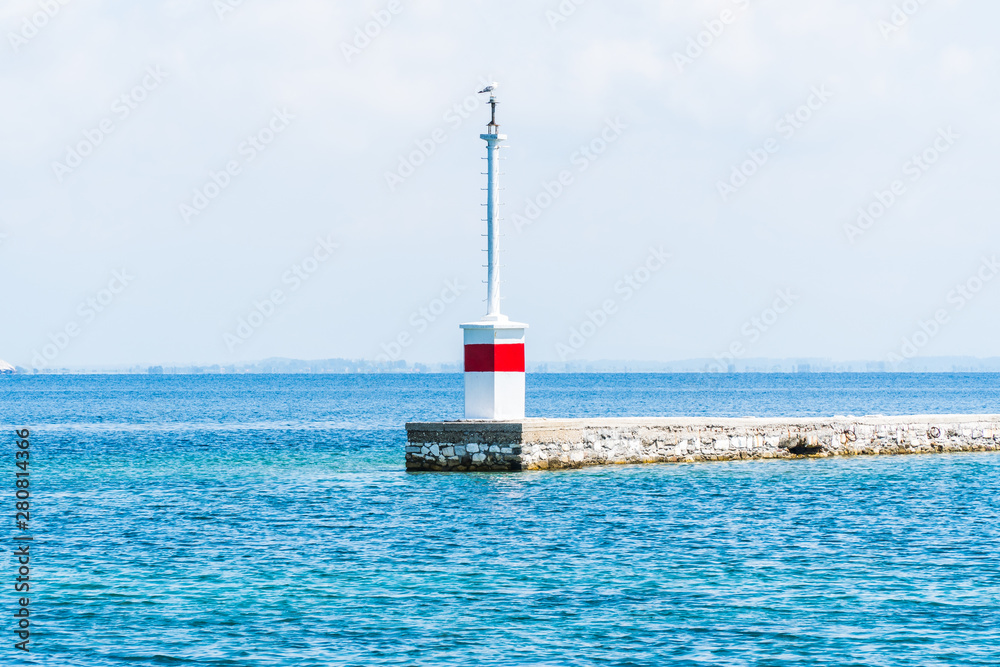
[0,374,1000,667]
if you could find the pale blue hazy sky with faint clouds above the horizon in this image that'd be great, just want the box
[0,0,1000,368]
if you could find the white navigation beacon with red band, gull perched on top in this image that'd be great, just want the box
[461,82,528,421]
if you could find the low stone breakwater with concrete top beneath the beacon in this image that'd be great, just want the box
[406,415,1000,472]
